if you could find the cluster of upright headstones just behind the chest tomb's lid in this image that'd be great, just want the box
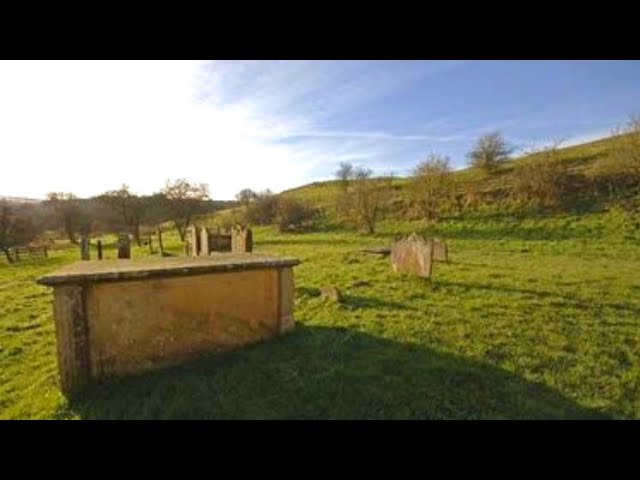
[185,225,253,257]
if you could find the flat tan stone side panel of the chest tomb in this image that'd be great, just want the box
[88,269,279,378]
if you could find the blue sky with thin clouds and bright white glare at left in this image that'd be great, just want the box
[0,60,640,200]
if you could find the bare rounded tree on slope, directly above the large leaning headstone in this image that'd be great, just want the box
[411,154,452,220]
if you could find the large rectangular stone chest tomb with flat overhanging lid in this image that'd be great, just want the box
[38,253,299,397]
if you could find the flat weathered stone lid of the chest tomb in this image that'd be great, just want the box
[37,253,300,286]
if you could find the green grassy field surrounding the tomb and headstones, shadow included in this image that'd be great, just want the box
[0,208,640,419]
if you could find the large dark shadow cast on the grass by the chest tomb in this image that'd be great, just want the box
[65,325,607,419]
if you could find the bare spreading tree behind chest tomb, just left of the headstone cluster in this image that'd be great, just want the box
[160,178,209,241]
